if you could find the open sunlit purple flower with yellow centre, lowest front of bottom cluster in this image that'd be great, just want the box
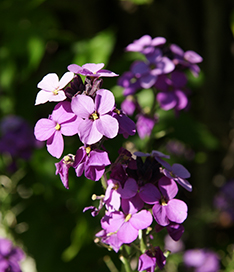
[101,198,152,244]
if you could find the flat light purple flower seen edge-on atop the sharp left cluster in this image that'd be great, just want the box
[67,63,118,77]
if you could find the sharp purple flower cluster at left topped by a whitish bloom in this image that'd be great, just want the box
[34,63,136,189]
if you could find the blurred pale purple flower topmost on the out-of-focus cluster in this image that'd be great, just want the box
[126,35,166,54]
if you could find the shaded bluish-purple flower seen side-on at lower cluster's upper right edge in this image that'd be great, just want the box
[163,163,192,192]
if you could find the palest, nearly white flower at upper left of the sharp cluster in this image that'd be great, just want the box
[35,72,74,105]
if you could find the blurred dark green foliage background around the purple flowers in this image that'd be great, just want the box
[0,0,234,272]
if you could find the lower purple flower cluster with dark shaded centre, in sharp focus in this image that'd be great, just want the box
[89,148,192,271]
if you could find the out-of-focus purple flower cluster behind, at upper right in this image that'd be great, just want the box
[118,35,202,138]
